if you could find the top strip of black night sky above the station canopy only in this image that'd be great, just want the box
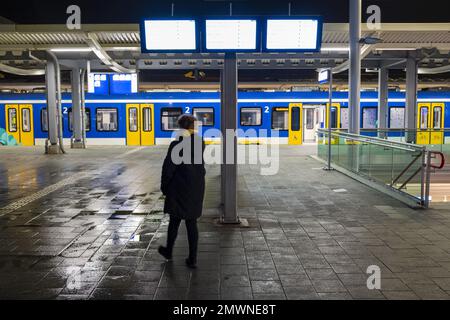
[0,0,450,24]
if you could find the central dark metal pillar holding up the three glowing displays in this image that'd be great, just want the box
[221,53,240,224]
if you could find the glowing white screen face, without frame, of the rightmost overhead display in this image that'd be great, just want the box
[266,19,319,50]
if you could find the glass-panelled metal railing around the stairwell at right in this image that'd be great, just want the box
[317,129,444,208]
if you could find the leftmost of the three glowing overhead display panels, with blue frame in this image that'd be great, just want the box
[141,19,198,53]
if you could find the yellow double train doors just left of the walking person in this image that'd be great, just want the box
[126,104,155,146]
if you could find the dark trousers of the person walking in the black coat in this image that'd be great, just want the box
[167,215,198,262]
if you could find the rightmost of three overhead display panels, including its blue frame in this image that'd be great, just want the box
[263,17,322,52]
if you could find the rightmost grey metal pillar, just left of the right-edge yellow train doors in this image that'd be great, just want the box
[405,54,417,143]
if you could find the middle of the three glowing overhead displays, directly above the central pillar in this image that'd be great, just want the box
[203,19,260,52]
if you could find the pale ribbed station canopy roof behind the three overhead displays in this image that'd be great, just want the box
[0,23,450,75]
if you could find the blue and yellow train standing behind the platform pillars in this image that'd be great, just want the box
[0,92,450,145]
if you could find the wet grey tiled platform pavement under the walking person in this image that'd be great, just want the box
[0,147,450,299]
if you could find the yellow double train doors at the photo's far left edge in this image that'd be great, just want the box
[5,104,34,146]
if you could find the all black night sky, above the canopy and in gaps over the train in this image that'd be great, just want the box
[0,0,450,83]
